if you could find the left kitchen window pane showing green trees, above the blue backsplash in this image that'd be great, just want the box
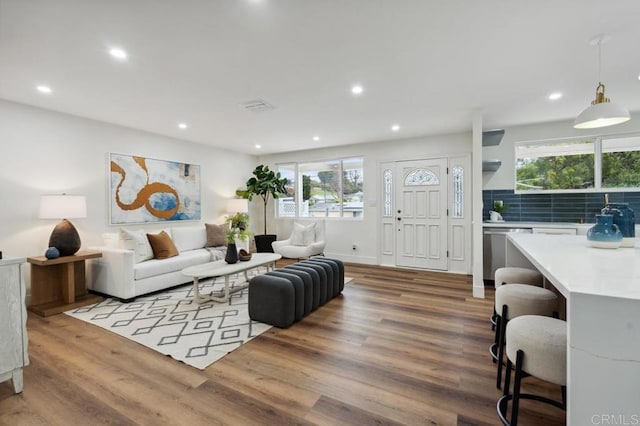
[516,139,595,191]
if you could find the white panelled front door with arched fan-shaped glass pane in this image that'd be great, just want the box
[394,158,448,270]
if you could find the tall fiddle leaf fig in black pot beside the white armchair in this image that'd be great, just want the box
[236,164,289,252]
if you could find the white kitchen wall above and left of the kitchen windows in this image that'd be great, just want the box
[482,112,640,189]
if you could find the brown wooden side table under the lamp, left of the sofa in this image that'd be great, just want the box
[27,250,102,317]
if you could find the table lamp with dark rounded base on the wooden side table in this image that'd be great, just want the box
[40,194,87,256]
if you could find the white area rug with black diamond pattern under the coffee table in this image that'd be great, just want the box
[65,274,271,370]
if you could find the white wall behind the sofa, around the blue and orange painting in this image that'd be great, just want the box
[0,100,257,282]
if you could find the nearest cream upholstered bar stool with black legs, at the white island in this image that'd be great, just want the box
[496,315,567,426]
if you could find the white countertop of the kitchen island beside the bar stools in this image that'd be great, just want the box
[507,233,640,300]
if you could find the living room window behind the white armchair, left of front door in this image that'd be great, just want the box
[278,158,364,217]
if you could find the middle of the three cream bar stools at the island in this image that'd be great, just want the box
[489,284,558,389]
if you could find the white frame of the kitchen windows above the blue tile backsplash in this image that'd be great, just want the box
[513,132,640,195]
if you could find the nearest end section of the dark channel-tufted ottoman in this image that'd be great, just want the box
[249,275,296,328]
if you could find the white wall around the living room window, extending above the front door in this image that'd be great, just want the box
[260,132,471,264]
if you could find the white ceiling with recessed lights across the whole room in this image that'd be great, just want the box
[0,0,640,154]
